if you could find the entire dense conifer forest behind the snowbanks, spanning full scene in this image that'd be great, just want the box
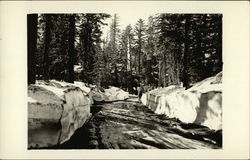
[28,14,222,92]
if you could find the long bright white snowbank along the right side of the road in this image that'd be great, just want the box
[141,73,222,130]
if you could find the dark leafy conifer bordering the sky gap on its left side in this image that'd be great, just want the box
[78,13,110,83]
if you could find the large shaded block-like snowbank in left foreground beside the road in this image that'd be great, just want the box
[28,80,91,148]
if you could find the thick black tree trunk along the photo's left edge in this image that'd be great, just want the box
[27,14,38,84]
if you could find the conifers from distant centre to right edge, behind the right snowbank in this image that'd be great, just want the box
[99,14,222,89]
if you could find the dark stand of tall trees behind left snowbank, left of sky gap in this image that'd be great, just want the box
[31,14,109,83]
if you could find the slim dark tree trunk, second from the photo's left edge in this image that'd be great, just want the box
[43,14,51,80]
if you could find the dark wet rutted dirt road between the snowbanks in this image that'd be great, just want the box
[47,98,222,149]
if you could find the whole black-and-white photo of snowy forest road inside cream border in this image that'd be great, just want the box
[27,13,223,150]
